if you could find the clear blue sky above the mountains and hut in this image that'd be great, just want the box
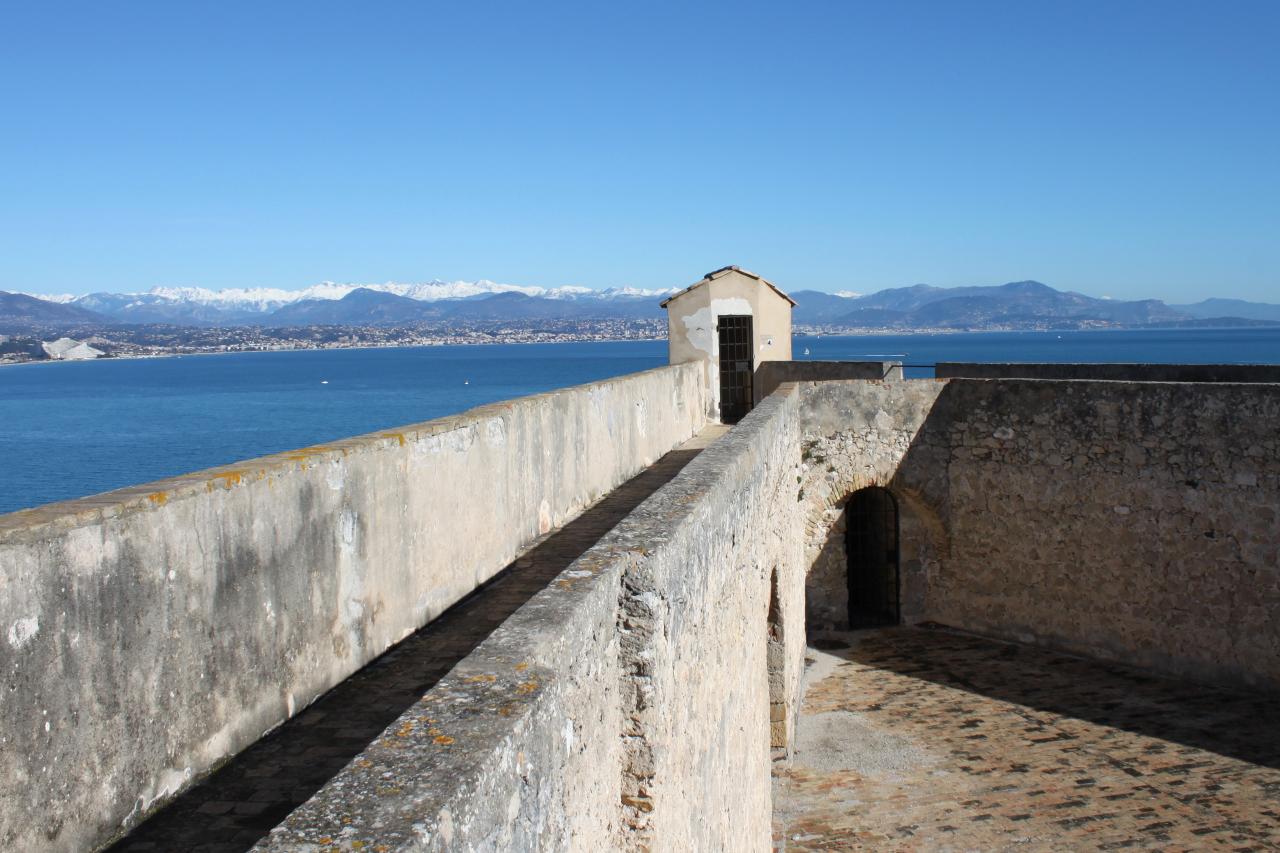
[0,0,1280,302]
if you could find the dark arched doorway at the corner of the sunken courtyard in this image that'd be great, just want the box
[845,487,899,628]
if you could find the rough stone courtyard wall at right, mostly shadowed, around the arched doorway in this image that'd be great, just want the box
[801,379,1280,690]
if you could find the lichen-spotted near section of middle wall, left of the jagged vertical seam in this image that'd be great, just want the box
[255,527,640,853]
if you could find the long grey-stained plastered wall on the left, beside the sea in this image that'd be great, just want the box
[0,364,707,850]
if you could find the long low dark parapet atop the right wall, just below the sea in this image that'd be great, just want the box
[933,361,1280,382]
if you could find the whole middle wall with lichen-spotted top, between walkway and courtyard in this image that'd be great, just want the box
[259,389,804,853]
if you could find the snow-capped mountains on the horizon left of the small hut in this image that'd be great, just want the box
[20,279,678,325]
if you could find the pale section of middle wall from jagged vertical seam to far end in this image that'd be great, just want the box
[620,387,804,850]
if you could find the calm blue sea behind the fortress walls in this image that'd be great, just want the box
[0,329,1280,512]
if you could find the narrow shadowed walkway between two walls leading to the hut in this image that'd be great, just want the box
[110,424,727,853]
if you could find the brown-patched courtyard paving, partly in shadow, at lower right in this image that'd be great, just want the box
[774,628,1280,850]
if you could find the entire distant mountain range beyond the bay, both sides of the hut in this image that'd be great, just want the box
[0,280,1280,330]
